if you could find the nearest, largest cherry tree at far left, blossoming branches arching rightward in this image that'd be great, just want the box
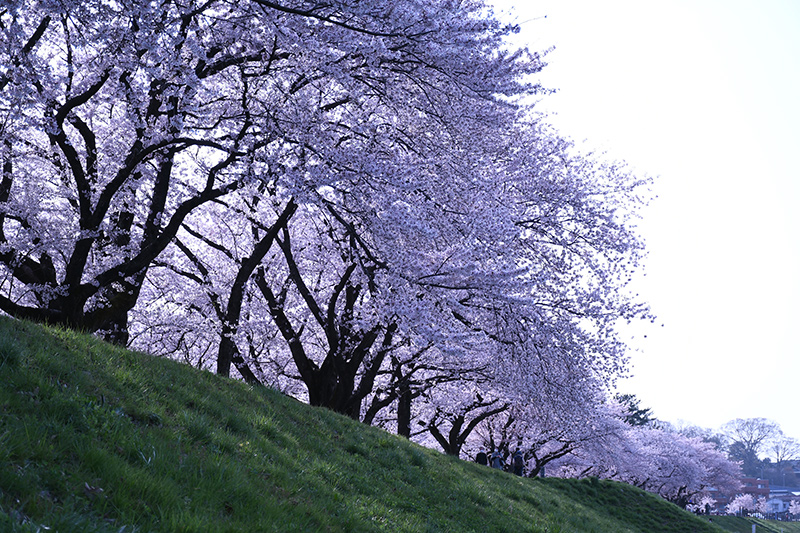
[0,0,541,340]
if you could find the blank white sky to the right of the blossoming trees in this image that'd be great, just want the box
[492,0,800,439]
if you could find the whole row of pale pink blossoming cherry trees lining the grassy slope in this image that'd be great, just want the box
[0,0,740,499]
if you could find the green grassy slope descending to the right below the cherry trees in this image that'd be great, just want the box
[0,318,740,533]
